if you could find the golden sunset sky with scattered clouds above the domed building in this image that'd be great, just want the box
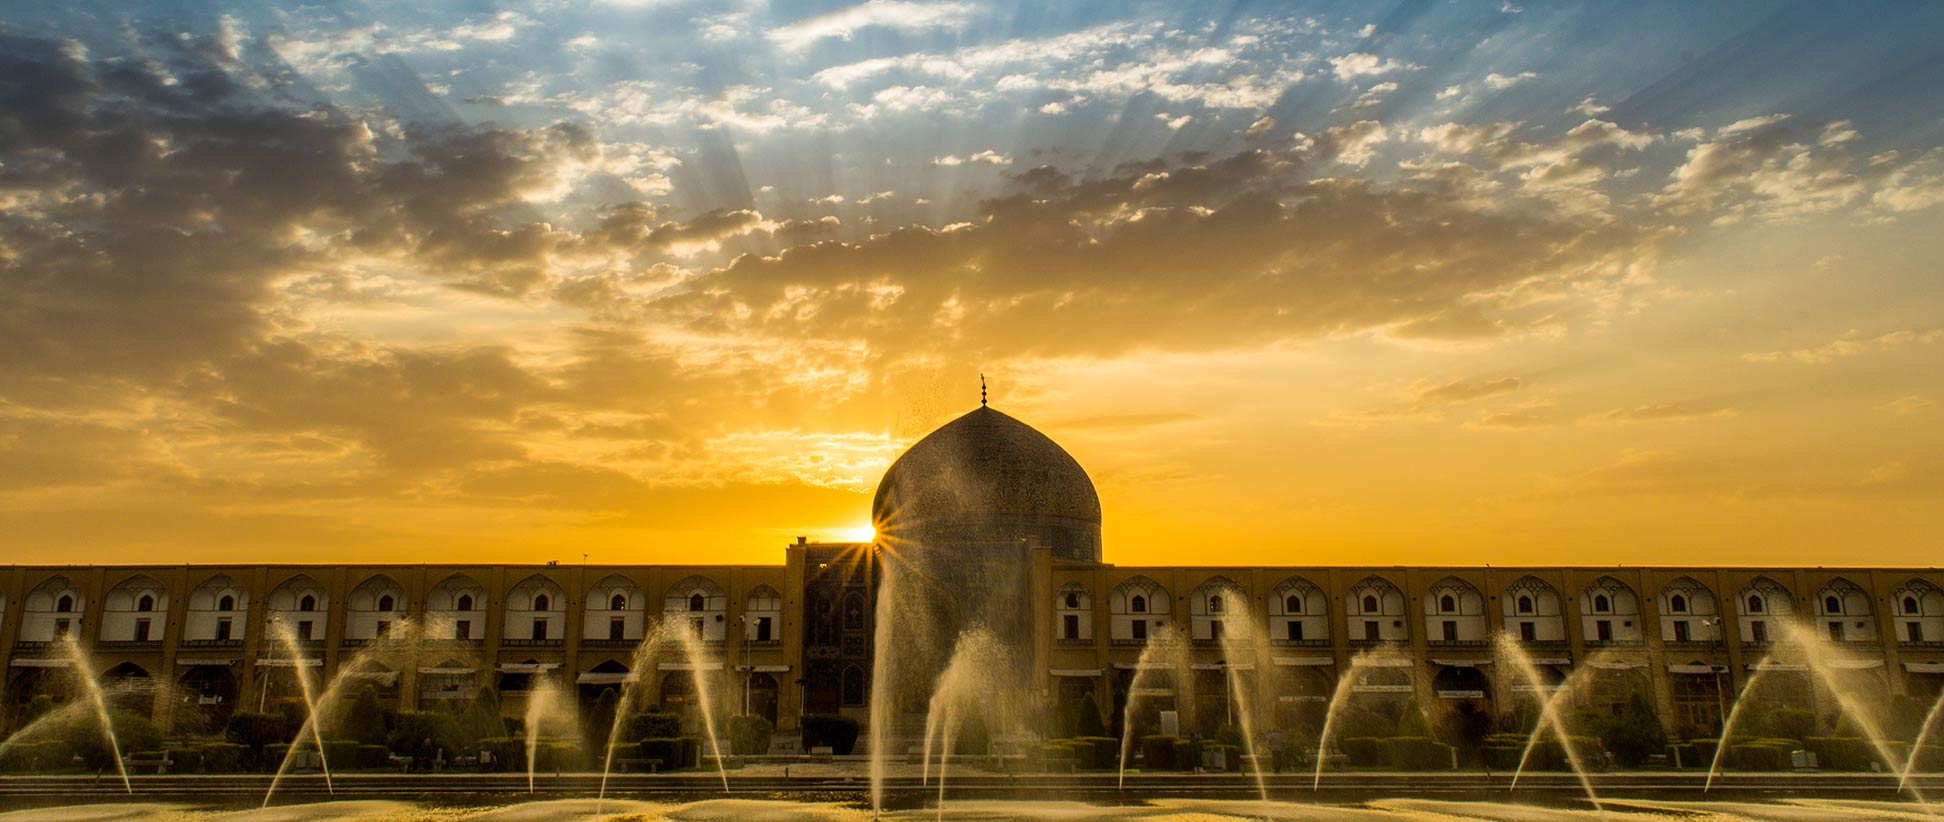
[0,0,1944,565]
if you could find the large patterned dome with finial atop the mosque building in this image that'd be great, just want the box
[871,406,1100,562]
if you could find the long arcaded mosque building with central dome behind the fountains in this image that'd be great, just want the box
[0,402,1944,736]
